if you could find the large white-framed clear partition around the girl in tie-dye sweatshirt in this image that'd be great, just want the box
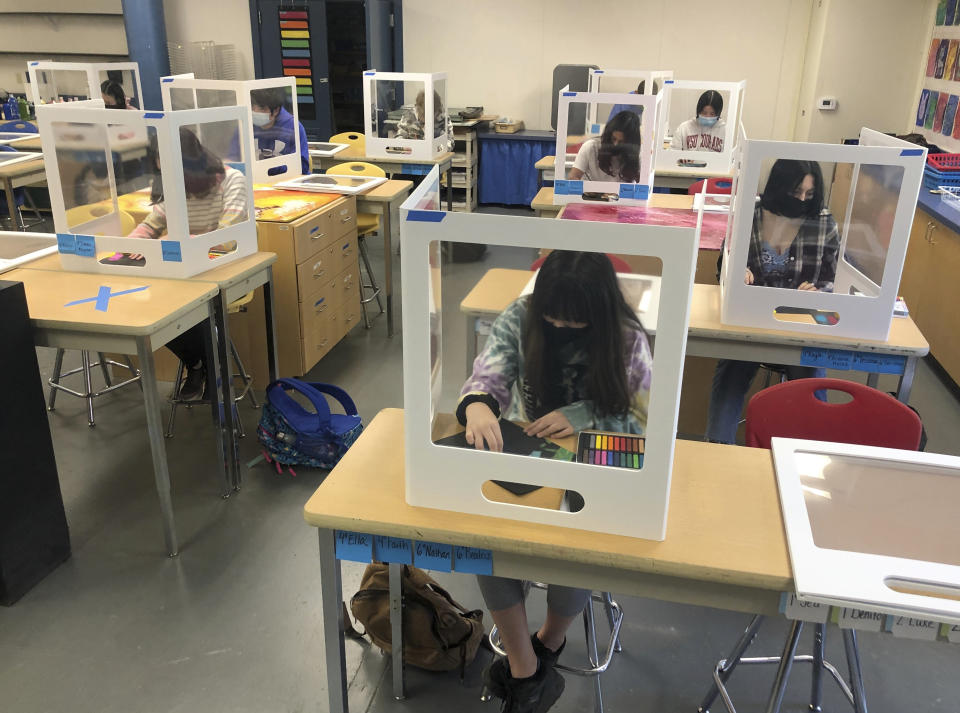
[401,169,697,539]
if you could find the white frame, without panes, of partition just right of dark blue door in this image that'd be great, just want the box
[363,69,449,161]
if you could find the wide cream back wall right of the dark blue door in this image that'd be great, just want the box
[403,0,814,139]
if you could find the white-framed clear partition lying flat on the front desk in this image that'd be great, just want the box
[771,438,960,623]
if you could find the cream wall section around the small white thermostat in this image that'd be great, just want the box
[795,0,936,143]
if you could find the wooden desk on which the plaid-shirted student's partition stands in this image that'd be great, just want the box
[460,268,930,403]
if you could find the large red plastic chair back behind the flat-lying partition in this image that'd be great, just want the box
[746,379,923,451]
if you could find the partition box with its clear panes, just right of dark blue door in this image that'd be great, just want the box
[363,70,451,160]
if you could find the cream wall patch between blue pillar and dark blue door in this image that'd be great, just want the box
[163,0,254,79]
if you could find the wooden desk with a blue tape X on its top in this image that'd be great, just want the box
[4,268,223,556]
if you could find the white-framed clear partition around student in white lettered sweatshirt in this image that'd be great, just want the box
[656,80,746,175]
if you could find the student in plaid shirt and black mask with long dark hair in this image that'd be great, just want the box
[706,159,840,443]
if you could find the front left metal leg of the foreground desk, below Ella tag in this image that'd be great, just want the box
[319,528,350,713]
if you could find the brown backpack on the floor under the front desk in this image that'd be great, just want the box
[350,562,483,677]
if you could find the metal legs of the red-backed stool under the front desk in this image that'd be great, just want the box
[697,614,867,713]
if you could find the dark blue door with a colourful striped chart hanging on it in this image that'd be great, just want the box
[254,0,332,140]
